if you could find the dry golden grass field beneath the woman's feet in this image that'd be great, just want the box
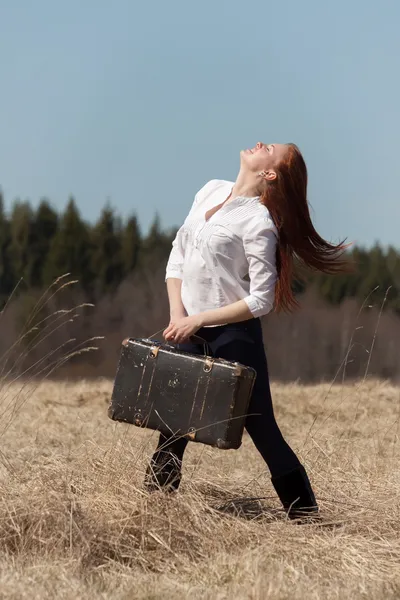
[0,380,400,600]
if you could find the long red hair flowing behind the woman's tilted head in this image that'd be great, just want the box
[261,144,349,312]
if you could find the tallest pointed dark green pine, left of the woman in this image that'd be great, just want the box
[43,198,93,289]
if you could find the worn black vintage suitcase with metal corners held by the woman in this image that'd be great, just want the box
[108,339,256,449]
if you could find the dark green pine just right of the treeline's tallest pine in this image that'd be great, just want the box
[92,205,123,294]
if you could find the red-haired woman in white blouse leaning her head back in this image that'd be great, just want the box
[146,142,345,518]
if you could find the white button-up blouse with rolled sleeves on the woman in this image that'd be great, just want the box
[166,179,278,317]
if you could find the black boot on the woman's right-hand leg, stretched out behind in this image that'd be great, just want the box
[271,466,319,520]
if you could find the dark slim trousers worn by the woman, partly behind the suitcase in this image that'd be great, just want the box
[158,319,300,478]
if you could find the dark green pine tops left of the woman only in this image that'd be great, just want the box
[0,195,175,301]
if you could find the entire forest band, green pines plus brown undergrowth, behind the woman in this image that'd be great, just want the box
[0,192,400,382]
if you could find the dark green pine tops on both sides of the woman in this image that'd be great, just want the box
[0,194,400,311]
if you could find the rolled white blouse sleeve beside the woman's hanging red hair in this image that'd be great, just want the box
[243,219,277,317]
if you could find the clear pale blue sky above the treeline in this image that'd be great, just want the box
[0,0,400,246]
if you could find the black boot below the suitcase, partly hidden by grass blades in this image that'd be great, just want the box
[144,450,182,492]
